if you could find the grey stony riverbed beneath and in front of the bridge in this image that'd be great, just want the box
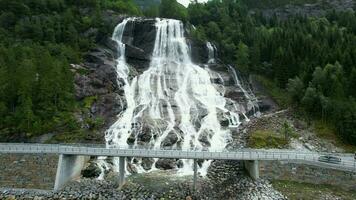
[0,161,286,200]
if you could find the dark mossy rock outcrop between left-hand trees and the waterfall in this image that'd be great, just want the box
[72,38,126,142]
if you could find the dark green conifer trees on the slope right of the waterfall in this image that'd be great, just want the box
[188,0,356,144]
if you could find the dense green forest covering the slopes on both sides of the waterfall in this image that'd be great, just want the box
[0,0,356,144]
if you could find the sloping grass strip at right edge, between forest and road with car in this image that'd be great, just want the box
[312,120,356,153]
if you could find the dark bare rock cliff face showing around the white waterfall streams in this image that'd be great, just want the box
[73,15,260,146]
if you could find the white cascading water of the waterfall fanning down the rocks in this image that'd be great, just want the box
[105,18,254,175]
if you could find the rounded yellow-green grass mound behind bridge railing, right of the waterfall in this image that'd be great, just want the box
[248,130,288,149]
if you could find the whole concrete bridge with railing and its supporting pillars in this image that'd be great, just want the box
[0,143,356,190]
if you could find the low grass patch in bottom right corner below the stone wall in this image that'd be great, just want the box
[272,180,356,200]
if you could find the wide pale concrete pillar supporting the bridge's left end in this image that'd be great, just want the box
[54,154,89,190]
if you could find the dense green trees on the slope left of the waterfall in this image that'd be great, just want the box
[0,0,141,140]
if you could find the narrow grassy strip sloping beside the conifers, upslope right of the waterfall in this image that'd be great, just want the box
[253,75,290,108]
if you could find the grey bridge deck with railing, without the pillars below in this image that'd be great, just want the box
[0,143,356,172]
